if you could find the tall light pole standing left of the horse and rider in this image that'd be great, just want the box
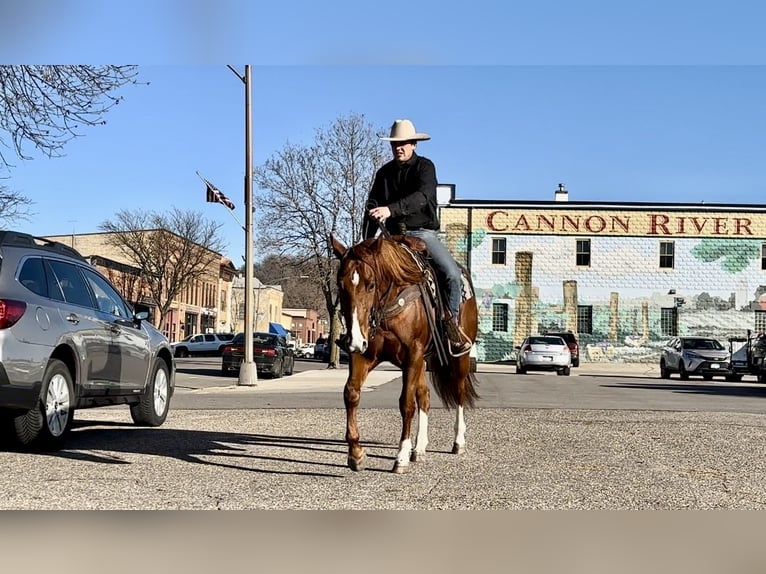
[228,65,258,386]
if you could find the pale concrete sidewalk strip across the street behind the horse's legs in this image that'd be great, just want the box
[184,362,660,393]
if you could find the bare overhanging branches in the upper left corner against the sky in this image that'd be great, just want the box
[0,66,138,170]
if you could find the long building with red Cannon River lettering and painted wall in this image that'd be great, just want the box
[440,186,766,363]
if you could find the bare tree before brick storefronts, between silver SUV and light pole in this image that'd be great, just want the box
[99,207,225,330]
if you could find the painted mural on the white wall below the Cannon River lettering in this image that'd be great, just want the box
[440,210,766,363]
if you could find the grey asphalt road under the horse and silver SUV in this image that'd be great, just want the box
[0,360,766,510]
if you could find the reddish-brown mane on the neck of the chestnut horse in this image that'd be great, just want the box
[349,236,423,285]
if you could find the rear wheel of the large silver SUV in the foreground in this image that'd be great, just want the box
[13,359,74,450]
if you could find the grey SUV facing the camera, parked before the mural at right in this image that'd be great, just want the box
[660,337,732,381]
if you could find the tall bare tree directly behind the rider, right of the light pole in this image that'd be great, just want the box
[254,114,390,364]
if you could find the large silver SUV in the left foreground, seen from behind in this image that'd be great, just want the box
[0,231,175,450]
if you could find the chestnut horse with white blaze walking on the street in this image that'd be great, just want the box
[330,236,478,473]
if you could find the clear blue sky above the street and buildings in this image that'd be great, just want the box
[0,0,766,264]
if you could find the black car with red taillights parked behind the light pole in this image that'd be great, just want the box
[221,333,295,379]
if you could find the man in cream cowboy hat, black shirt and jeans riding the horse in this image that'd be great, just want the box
[363,120,471,357]
